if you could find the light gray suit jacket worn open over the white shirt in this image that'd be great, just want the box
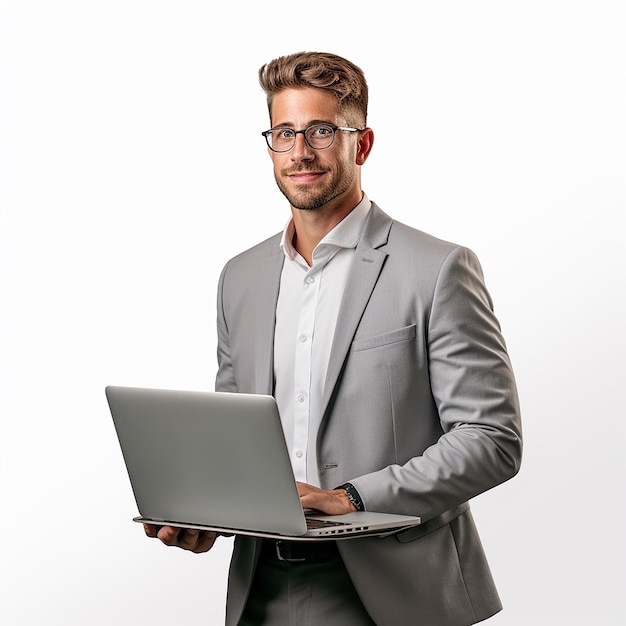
[216,205,522,626]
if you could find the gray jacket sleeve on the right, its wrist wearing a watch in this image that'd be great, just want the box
[350,247,522,519]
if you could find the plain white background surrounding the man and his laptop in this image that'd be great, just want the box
[0,0,626,626]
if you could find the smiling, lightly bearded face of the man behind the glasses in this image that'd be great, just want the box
[269,87,360,210]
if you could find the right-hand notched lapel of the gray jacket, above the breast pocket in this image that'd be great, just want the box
[320,203,392,430]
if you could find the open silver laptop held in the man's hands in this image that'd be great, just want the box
[105,386,421,541]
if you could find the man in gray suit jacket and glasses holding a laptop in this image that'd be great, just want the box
[146,53,521,626]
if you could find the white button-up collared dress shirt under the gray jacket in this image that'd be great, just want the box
[274,195,371,486]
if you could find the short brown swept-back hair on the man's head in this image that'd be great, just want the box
[259,52,367,127]
